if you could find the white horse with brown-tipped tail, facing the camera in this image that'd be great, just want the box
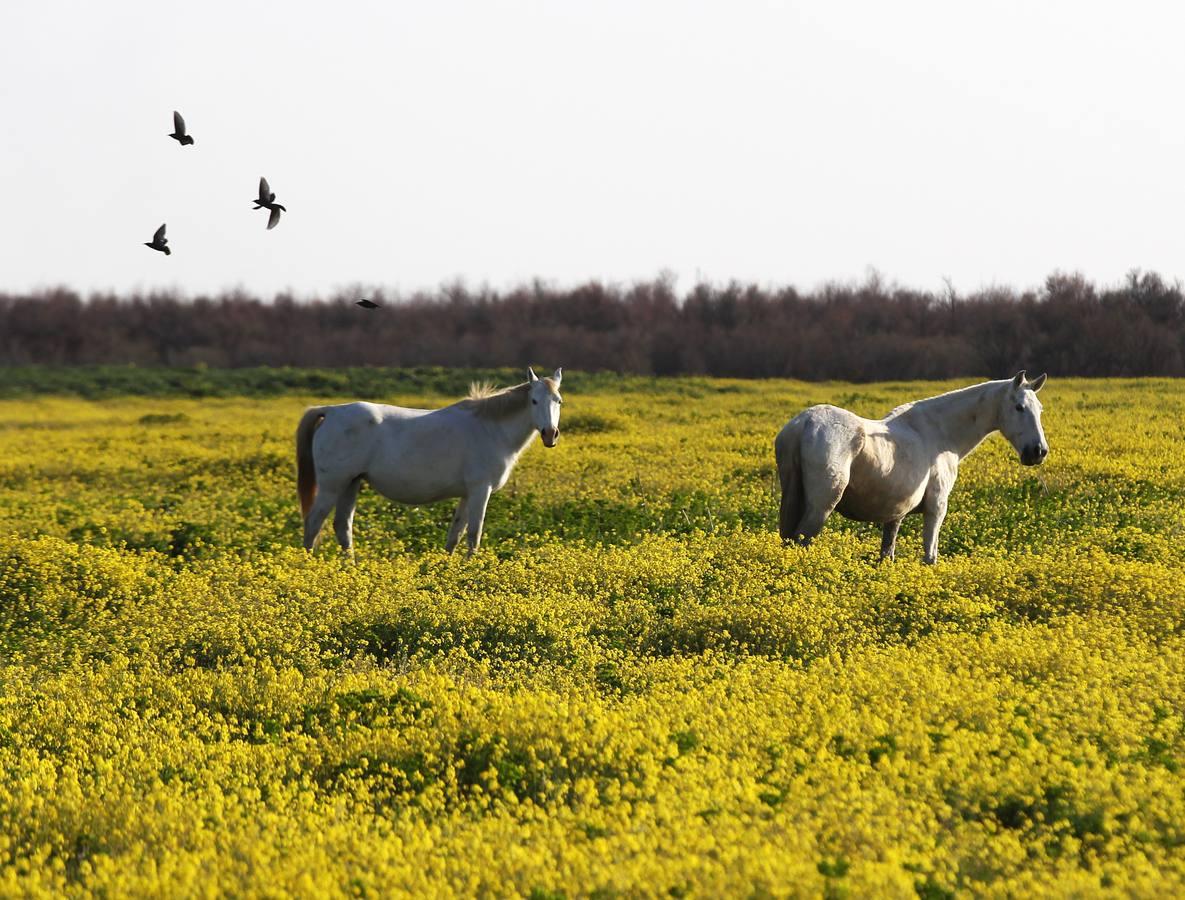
[296,369,563,556]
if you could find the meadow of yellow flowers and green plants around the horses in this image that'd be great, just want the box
[0,370,1185,900]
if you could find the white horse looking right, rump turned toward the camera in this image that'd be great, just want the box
[774,371,1049,563]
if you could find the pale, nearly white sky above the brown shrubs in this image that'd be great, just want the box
[0,0,1185,296]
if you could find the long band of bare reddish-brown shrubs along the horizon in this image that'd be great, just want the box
[0,272,1185,379]
